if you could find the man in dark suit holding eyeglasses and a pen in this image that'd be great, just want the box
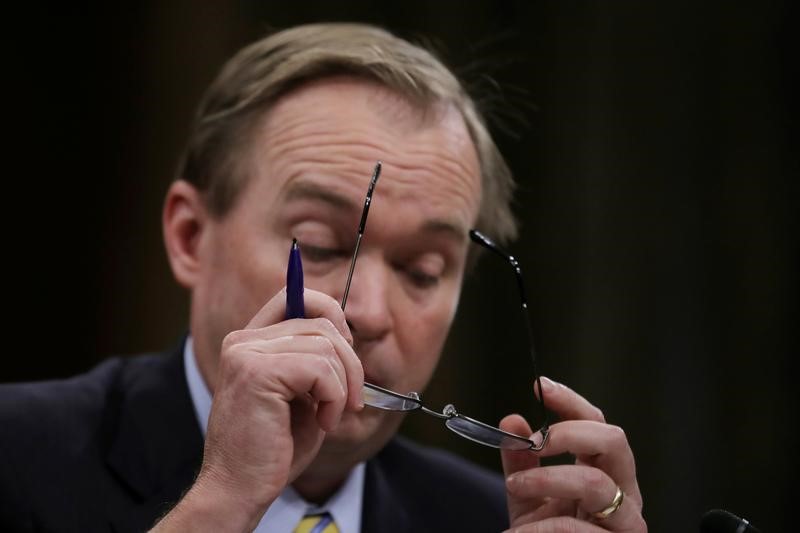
[0,25,646,531]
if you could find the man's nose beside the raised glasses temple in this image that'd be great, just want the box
[345,254,394,342]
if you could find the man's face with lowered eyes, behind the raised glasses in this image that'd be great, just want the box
[192,78,481,460]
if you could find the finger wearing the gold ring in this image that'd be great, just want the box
[507,465,638,530]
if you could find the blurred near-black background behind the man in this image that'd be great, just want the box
[0,0,800,532]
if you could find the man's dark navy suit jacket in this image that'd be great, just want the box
[0,348,508,532]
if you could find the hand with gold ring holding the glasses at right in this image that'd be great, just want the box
[500,378,647,533]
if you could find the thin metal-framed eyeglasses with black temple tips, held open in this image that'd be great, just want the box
[341,161,550,451]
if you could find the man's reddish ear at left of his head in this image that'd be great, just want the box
[161,180,209,289]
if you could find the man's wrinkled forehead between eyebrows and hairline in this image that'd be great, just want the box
[241,77,481,230]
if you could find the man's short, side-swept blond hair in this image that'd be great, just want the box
[177,23,517,242]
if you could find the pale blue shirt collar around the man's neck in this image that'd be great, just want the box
[183,335,365,533]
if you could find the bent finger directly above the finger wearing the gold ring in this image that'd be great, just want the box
[538,420,641,501]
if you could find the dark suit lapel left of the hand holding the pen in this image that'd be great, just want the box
[106,343,203,531]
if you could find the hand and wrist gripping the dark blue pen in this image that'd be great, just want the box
[154,289,364,530]
